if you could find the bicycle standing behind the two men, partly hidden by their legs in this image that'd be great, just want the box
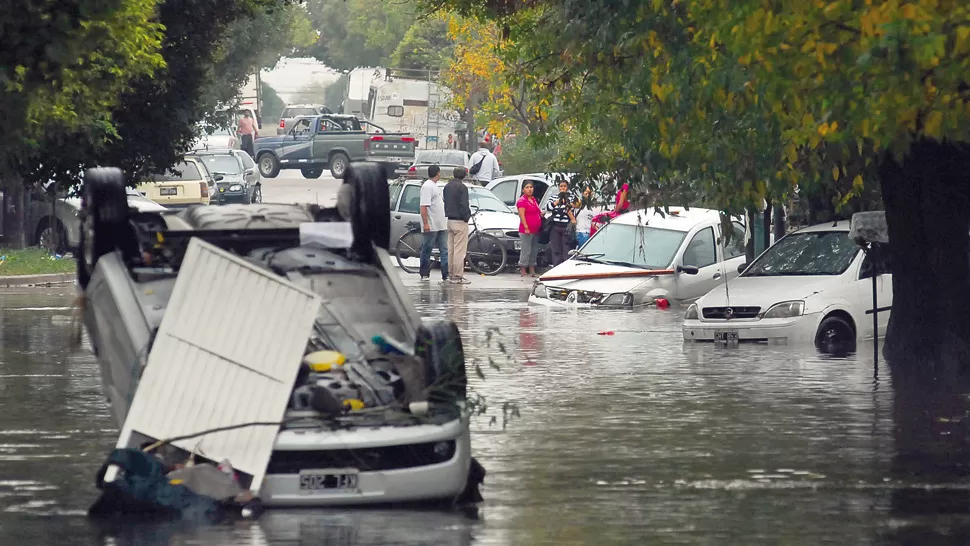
[394,209,509,276]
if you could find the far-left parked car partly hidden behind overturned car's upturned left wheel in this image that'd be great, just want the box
[25,182,166,254]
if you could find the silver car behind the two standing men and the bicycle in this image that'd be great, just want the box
[389,176,522,263]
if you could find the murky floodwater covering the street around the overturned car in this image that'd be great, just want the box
[0,277,970,546]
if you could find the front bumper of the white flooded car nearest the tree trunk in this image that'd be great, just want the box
[682,314,818,345]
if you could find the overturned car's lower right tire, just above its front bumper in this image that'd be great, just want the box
[414,320,468,403]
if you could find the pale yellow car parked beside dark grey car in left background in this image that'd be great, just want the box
[136,156,223,207]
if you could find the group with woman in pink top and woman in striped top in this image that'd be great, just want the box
[515,179,630,277]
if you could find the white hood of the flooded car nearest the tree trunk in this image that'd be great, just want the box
[697,275,838,310]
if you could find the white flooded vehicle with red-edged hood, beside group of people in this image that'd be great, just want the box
[529,207,745,308]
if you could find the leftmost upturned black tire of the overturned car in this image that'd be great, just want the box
[76,167,137,290]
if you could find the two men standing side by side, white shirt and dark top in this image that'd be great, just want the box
[418,165,472,284]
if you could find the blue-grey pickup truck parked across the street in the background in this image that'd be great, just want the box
[254,114,415,178]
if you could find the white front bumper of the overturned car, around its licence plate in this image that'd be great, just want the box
[259,420,471,507]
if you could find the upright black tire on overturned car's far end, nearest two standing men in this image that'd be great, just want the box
[344,158,391,250]
